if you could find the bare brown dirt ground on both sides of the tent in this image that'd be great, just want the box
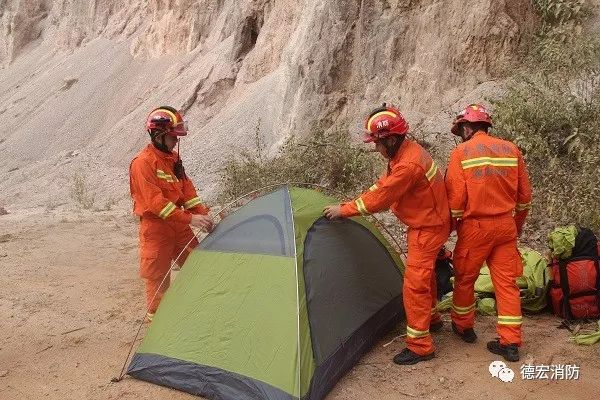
[0,210,600,400]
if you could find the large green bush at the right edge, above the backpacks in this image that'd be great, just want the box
[493,33,600,229]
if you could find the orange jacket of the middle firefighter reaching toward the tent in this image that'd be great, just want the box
[341,139,450,228]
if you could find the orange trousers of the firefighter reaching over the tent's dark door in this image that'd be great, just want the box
[402,225,450,355]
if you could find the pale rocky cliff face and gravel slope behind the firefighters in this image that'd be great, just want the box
[0,0,535,207]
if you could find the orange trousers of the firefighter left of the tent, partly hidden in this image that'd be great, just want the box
[139,217,198,314]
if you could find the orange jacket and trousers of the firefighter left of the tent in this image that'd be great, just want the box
[129,144,209,314]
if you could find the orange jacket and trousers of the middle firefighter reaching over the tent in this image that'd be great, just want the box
[341,139,450,355]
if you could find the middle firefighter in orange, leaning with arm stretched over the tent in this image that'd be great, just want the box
[324,104,450,365]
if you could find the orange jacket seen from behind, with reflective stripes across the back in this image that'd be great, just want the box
[446,132,531,232]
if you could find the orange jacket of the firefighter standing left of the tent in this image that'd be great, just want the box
[129,144,209,224]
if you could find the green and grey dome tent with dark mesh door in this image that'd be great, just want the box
[127,186,404,400]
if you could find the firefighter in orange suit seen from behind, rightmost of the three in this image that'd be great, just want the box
[446,104,531,361]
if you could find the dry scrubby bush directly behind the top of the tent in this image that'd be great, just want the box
[218,123,381,202]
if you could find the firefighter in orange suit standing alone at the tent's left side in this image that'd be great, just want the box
[129,106,213,321]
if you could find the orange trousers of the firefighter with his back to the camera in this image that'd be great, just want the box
[452,216,523,346]
